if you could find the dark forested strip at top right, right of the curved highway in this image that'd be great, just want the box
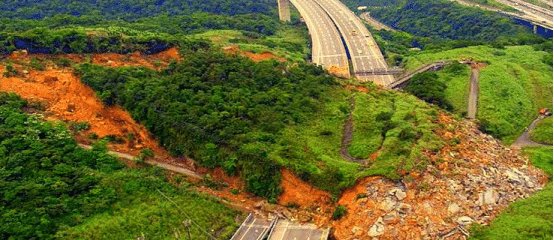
[347,0,539,45]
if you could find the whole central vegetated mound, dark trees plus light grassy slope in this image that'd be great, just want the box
[73,49,440,199]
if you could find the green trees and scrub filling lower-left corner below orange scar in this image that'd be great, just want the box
[0,93,240,239]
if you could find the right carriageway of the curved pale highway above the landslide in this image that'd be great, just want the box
[310,0,394,86]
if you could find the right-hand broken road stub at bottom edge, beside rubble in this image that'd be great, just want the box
[268,220,329,240]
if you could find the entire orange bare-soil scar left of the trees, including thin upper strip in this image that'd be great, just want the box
[0,49,261,210]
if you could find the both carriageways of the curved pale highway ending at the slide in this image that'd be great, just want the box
[290,0,394,86]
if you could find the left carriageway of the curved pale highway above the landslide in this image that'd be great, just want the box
[291,0,350,78]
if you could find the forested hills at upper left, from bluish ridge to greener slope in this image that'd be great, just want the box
[0,1,279,54]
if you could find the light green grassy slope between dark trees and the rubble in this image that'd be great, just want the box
[271,85,443,194]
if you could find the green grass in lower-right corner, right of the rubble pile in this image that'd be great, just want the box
[471,147,552,240]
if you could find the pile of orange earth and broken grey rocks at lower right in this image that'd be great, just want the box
[333,116,547,239]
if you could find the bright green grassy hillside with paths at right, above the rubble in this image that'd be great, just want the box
[406,46,552,143]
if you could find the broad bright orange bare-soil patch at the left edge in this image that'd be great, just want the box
[0,66,168,156]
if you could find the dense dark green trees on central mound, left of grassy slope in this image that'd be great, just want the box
[75,50,334,197]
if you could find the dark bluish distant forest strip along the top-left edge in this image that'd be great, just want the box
[0,0,277,20]
